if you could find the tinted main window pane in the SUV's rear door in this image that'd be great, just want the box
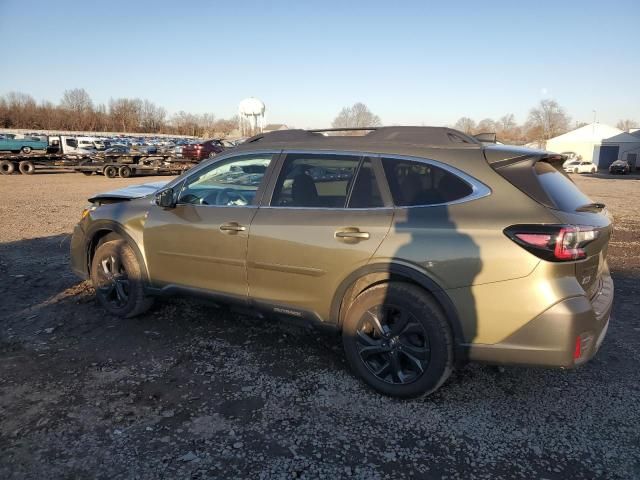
[271,153,360,208]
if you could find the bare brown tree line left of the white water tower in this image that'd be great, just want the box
[0,88,238,137]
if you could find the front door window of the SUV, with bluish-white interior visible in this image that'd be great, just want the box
[178,154,274,207]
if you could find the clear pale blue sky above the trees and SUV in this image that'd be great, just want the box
[0,0,640,128]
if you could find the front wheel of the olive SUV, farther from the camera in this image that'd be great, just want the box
[91,240,153,318]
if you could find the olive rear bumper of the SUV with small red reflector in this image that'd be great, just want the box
[467,275,614,368]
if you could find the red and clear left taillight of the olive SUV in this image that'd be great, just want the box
[504,225,598,262]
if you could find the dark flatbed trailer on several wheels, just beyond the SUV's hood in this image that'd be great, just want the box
[73,153,198,178]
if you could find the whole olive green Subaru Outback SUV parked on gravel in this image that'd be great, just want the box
[71,127,613,397]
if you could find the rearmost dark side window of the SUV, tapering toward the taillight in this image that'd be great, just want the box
[382,158,472,207]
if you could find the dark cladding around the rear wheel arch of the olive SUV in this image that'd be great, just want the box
[331,263,465,358]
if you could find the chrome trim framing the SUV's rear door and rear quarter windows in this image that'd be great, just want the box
[260,148,491,211]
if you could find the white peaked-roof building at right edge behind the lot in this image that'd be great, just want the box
[546,123,640,170]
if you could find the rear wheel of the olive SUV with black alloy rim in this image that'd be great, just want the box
[342,282,454,398]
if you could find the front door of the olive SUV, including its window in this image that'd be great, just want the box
[144,153,276,298]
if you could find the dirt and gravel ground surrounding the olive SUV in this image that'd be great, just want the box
[0,174,640,479]
